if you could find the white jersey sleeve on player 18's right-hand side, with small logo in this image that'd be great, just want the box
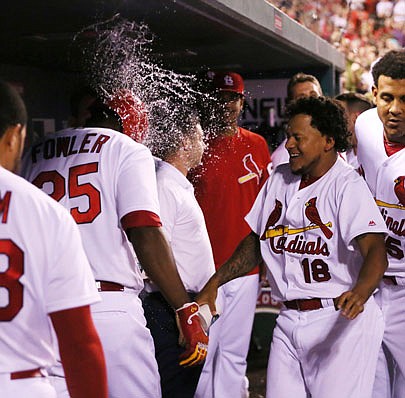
[338,175,387,250]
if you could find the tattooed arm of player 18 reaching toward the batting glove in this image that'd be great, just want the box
[196,232,262,315]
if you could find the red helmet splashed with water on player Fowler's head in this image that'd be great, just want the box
[107,89,148,142]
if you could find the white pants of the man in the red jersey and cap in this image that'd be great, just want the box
[195,274,259,398]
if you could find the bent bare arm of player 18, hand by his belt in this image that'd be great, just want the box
[337,233,388,319]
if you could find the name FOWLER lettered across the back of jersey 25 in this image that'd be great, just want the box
[31,133,111,163]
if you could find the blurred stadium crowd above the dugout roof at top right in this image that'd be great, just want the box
[267,0,405,94]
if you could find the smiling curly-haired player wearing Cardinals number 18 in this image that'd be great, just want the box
[198,97,387,398]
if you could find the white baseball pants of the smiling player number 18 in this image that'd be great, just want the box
[266,297,384,398]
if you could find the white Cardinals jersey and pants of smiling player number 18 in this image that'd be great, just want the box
[246,158,386,398]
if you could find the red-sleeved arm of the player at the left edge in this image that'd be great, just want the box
[49,306,108,398]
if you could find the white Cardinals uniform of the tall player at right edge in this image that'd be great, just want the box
[355,108,405,398]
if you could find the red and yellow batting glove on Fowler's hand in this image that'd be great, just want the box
[176,303,208,367]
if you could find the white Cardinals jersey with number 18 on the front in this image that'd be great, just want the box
[246,158,386,301]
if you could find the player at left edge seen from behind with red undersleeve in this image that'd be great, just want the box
[0,82,107,398]
